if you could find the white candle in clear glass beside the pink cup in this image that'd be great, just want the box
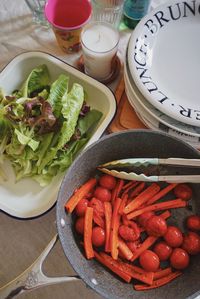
[81,22,119,80]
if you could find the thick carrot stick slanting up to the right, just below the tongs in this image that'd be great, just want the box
[124,183,160,214]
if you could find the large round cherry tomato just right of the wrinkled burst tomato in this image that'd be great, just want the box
[146,215,167,237]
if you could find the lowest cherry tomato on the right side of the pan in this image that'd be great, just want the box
[170,248,190,270]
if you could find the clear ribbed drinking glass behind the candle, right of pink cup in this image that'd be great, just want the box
[92,0,124,28]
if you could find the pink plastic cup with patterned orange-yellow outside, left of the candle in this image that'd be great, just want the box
[44,0,92,54]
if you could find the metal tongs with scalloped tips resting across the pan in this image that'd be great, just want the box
[98,158,200,183]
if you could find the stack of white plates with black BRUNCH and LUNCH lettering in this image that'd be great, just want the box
[124,0,200,149]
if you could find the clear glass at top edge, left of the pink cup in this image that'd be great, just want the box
[25,0,49,27]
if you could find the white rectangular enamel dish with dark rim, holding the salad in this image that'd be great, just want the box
[0,52,116,218]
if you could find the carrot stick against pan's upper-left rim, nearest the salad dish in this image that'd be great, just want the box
[65,178,97,213]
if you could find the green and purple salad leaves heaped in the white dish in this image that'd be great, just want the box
[0,65,102,186]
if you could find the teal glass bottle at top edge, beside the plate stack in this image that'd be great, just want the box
[123,0,151,29]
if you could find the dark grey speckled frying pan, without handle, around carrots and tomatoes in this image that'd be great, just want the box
[57,130,200,299]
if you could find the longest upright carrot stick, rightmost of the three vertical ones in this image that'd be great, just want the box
[110,197,122,260]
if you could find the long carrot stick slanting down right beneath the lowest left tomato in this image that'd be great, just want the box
[100,252,154,285]
